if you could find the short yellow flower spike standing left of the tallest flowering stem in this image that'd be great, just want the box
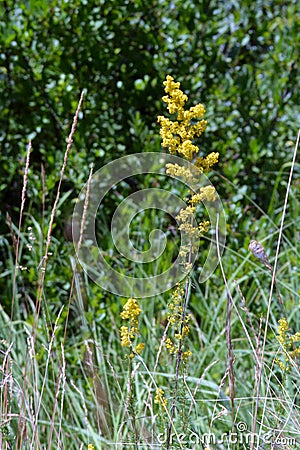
[120,298,145,358]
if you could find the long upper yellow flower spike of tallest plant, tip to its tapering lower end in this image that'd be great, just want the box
[158,75,219,272]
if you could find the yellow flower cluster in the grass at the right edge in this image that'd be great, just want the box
[275,317,300,372]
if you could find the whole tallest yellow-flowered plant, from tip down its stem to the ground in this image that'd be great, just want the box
[157,75,219,449]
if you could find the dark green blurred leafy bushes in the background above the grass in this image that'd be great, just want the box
[0,0,300,446]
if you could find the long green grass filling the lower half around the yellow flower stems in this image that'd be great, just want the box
[0,106,300,450]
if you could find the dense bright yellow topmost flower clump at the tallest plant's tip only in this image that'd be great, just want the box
[157,75,207,161]
